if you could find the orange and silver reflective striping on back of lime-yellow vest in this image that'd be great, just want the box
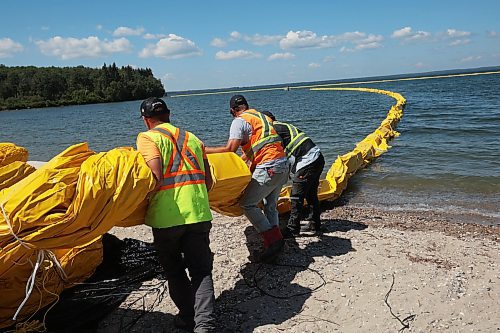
[151,127,205,190]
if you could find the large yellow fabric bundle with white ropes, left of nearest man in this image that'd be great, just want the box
[0,144,155,328]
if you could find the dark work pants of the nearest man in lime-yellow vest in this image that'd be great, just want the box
[153,221,215,332]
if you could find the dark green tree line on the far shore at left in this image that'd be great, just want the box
[0,63,165,110]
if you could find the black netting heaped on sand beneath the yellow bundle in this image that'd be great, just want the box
[40,234,163,332]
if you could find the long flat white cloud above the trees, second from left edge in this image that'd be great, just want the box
[35,36,132,60]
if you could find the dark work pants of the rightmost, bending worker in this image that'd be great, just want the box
[287,154,325,231]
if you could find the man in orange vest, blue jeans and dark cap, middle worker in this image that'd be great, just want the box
[206,95,290,263]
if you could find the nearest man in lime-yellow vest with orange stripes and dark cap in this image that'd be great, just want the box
[137,97,215,332]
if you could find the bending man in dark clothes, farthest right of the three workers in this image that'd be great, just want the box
[262,111,325,238]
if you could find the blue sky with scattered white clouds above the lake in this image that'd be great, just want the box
[0,0,500,91]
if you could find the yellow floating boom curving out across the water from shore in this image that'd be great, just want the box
[278,88,406,213]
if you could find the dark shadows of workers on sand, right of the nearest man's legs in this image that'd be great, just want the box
[217,214,366,332]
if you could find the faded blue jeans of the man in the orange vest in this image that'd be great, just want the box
[240,161,290,233]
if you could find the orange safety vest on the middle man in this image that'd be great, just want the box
[238,109,286,166]
